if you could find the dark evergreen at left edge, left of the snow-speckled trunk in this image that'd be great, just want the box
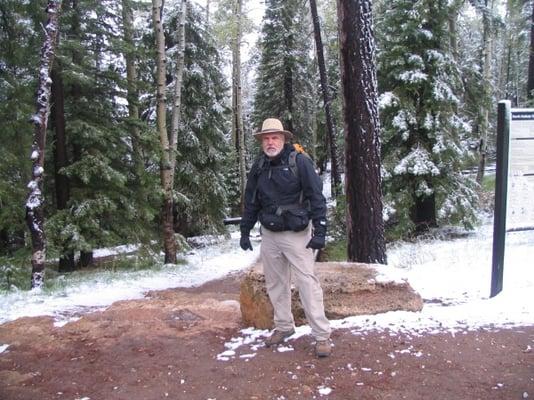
[0,0,46,256]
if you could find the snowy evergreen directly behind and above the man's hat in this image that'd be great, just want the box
[253,0,316,147]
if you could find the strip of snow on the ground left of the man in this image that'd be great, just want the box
[0,232,259,325]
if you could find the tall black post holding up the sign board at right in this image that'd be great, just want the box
[490,100,511,297]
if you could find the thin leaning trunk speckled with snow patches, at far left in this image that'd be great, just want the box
[26,0,61,288]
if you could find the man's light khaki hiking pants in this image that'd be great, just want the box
[260,224,331,340]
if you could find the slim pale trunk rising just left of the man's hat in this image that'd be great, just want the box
[232,0,247,213]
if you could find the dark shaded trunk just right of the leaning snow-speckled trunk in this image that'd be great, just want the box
[52,63,75,272]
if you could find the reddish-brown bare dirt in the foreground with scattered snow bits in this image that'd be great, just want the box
[0,275,534,400]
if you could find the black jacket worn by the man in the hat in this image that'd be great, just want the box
[240,143,326,236]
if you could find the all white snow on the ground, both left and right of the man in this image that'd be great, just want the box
[0,214,534,335]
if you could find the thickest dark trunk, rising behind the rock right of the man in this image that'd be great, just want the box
[337,0,386,264]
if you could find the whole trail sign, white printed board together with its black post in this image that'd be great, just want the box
[490,100,534,297]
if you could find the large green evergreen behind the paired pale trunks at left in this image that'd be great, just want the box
[48,1,161,266]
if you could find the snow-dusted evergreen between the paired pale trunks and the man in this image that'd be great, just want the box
[166,3,231,236]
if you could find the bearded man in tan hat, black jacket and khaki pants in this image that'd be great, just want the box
[240,118,331,357]
